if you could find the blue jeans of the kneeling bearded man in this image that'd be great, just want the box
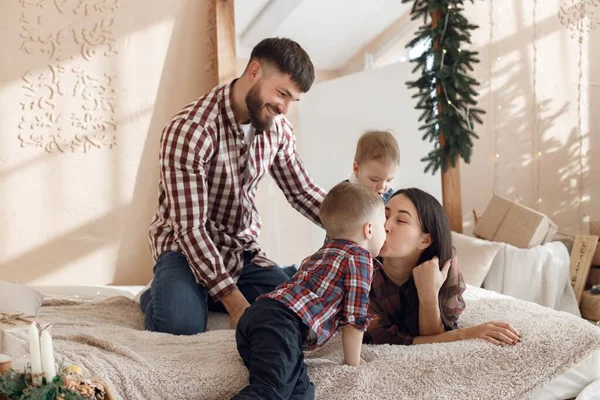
[140,251,296,335]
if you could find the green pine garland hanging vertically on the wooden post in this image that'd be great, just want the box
[402,0,485,173]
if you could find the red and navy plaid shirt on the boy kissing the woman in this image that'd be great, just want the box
[259,239,380,350]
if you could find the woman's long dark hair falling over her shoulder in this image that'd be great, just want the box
[390,188,452,268]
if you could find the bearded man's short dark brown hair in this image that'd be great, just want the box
[246,38,315,93]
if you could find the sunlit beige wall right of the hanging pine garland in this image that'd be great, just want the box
[461,0,600,234]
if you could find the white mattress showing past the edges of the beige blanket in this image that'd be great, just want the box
[32,285,600,400]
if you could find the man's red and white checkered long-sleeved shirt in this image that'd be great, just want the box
[149,81,325,301]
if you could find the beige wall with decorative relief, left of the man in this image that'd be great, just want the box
[0,0,216,284]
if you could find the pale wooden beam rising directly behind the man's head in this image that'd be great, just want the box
[211,0,237,85]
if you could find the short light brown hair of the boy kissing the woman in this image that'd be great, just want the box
[319,182,383,239]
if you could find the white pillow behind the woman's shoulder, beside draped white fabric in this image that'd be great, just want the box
[452,232,502,287]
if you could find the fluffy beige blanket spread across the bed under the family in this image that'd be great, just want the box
[31,287,600,400]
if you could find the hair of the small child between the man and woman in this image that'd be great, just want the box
[354,130,400,164]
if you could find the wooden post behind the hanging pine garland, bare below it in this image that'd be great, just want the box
[431,10,463,233]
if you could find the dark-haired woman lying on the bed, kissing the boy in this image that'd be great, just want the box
[364,188,520,345]
